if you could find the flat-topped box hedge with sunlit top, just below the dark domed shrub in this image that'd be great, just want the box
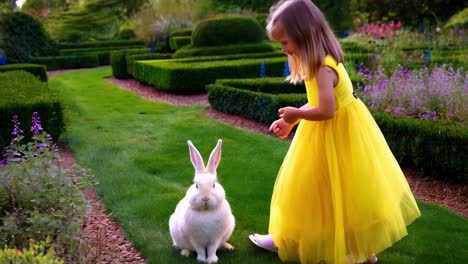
[133,57,286,93]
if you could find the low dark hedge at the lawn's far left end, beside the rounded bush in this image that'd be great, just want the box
[32,54,100,71]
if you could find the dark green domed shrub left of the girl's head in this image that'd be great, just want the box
[192,17,265,47]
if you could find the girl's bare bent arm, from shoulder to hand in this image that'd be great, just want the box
[278,66,338,124]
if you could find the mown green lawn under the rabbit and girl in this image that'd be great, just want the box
[49,68,468,264]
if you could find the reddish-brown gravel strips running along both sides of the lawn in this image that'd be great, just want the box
[48,70,468,264]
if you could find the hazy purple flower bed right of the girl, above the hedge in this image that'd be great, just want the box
[359,65,468,126]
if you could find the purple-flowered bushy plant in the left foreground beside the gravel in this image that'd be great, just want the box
[0,112,94,255]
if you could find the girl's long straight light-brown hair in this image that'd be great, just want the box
[266,0,343,83]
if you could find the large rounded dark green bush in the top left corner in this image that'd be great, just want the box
[0,12,57,63]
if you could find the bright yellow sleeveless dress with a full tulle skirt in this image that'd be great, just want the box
[269,56,420,264]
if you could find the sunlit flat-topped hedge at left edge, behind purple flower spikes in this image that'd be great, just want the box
[0,71,65,149]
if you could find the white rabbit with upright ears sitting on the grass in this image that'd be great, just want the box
[169,139,235,263]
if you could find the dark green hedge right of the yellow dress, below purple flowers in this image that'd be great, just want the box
[372,112,468,184]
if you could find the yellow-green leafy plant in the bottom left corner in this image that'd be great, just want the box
[0,238,65,264]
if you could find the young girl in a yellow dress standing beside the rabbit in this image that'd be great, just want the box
[249,0,420,264]
